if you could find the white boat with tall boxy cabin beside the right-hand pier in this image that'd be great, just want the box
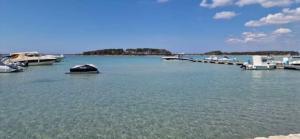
[241,56,276,70]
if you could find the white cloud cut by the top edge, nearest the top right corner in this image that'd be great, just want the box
[236,0,298,8]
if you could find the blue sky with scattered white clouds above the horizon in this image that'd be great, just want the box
[0,0,300,53]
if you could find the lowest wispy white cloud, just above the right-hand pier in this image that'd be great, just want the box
[226,28,292,44]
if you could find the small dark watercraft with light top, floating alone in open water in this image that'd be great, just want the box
[67,64,99,74]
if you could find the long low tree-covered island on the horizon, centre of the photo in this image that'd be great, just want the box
[82,48,172,55]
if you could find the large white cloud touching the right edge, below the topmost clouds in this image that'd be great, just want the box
[245,7,300,27]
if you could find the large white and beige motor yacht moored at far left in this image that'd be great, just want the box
[4,52,56,66]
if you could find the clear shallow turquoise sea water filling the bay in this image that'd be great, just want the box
[0,56,300,139]
